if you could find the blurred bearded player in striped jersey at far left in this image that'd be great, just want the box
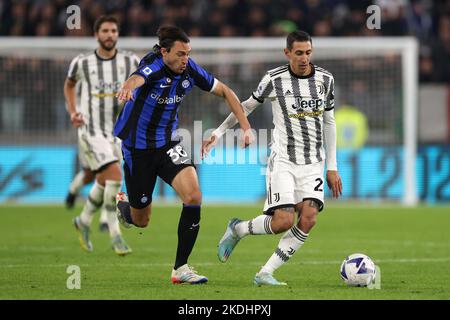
[64,16,138,255]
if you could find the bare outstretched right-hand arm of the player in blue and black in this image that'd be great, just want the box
[211,81,254,149]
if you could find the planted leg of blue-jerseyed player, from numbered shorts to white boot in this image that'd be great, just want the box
[158,144,208,284]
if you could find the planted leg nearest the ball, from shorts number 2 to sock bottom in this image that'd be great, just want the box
[255,163,323,284]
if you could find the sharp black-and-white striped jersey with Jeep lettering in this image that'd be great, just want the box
[252,64,334,164]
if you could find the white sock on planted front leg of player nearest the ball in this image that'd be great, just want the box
[260,226,308,274]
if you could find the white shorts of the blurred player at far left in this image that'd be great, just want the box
[78,133,122,172]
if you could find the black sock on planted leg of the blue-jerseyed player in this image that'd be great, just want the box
[174,204,201,270]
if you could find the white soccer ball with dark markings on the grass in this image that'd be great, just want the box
[341,253,376,287]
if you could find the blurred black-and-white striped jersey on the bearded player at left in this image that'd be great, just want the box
[67,50,139,139]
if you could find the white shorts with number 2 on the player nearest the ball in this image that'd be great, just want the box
[264,151,325,214]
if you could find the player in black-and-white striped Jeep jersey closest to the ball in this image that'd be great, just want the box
[202,31,342,285]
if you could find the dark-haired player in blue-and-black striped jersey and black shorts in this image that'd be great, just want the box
[114,26,252,284]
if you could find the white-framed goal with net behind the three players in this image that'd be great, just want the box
[0,37,417,205]
